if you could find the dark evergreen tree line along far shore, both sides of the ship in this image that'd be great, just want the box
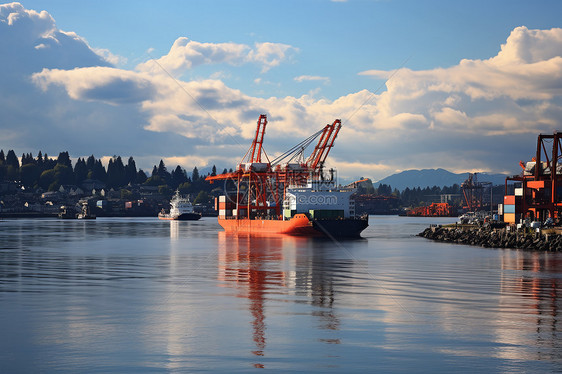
[0,150,484,206]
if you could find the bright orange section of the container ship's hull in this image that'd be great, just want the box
[215,214,322,236]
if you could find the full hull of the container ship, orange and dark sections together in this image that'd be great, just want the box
[218,214,368,238]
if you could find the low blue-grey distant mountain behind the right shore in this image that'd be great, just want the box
[374,169,506,191]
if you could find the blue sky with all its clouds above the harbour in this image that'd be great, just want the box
[0,0,562,181]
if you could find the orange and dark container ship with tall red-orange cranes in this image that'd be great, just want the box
[207,114,368,238]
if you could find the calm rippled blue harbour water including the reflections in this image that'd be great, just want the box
[0,216,562,373]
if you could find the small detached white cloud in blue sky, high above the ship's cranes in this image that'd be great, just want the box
[137,37,297,74]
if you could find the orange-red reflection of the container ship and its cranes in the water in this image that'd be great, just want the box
[217,232,363,367]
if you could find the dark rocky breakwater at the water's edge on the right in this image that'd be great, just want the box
[418,226,562,251]
